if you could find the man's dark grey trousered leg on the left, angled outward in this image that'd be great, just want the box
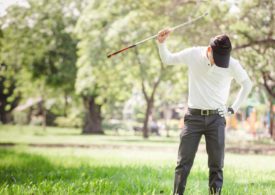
[173,116,202,195]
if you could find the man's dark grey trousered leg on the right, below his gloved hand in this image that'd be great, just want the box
[205,115,225,194]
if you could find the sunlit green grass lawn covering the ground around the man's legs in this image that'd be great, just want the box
[0,125,275,195]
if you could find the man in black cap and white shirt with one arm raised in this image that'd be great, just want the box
[157,29,252,195]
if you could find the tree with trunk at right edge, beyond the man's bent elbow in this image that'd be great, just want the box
[231,0,275,139]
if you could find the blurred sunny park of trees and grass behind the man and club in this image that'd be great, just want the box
[0,0,275,194]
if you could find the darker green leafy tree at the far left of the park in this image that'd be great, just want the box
[0,0,84,124]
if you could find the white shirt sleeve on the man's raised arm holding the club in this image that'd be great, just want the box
[158,43,193,65]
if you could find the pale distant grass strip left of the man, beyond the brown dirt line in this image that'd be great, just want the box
[0,125,179,146]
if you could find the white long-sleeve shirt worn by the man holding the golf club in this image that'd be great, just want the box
[158,43,252,112]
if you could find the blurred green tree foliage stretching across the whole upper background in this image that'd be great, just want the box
[0,0,275,125]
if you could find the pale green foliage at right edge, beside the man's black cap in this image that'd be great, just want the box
[228,0,275,103]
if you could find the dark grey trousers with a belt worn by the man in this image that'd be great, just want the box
[173,113,226,195]
